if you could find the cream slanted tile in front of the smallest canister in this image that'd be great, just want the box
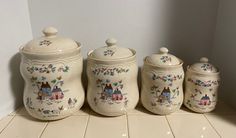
[167,114,219,138]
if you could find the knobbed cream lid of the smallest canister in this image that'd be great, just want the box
[189,57,218,73]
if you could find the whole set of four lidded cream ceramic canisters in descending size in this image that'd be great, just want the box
[20,27,220,120]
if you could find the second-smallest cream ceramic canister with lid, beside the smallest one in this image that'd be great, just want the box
[141,47,184,115]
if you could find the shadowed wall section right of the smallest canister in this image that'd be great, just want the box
[212,0,236,108]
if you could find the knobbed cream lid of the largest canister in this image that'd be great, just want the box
[21,27,80,55]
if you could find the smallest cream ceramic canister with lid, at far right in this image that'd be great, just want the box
[184,57,220,113]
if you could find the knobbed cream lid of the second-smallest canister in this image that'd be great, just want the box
[146,47,181,66]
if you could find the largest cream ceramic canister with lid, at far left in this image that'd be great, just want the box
[20,27,84,120]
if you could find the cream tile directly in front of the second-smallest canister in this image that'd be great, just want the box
[128,115,173,138]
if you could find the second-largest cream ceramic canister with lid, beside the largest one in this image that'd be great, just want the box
[87,38,139,116]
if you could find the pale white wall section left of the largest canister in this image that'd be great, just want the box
[0,0,32,118]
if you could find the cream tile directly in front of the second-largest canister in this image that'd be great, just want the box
[85,115,128,138]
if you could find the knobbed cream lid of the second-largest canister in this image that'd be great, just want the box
[88,38,133,60]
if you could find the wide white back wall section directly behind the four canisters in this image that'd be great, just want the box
[29,0,218,65]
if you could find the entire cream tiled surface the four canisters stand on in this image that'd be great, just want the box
[0,103,236,138]
